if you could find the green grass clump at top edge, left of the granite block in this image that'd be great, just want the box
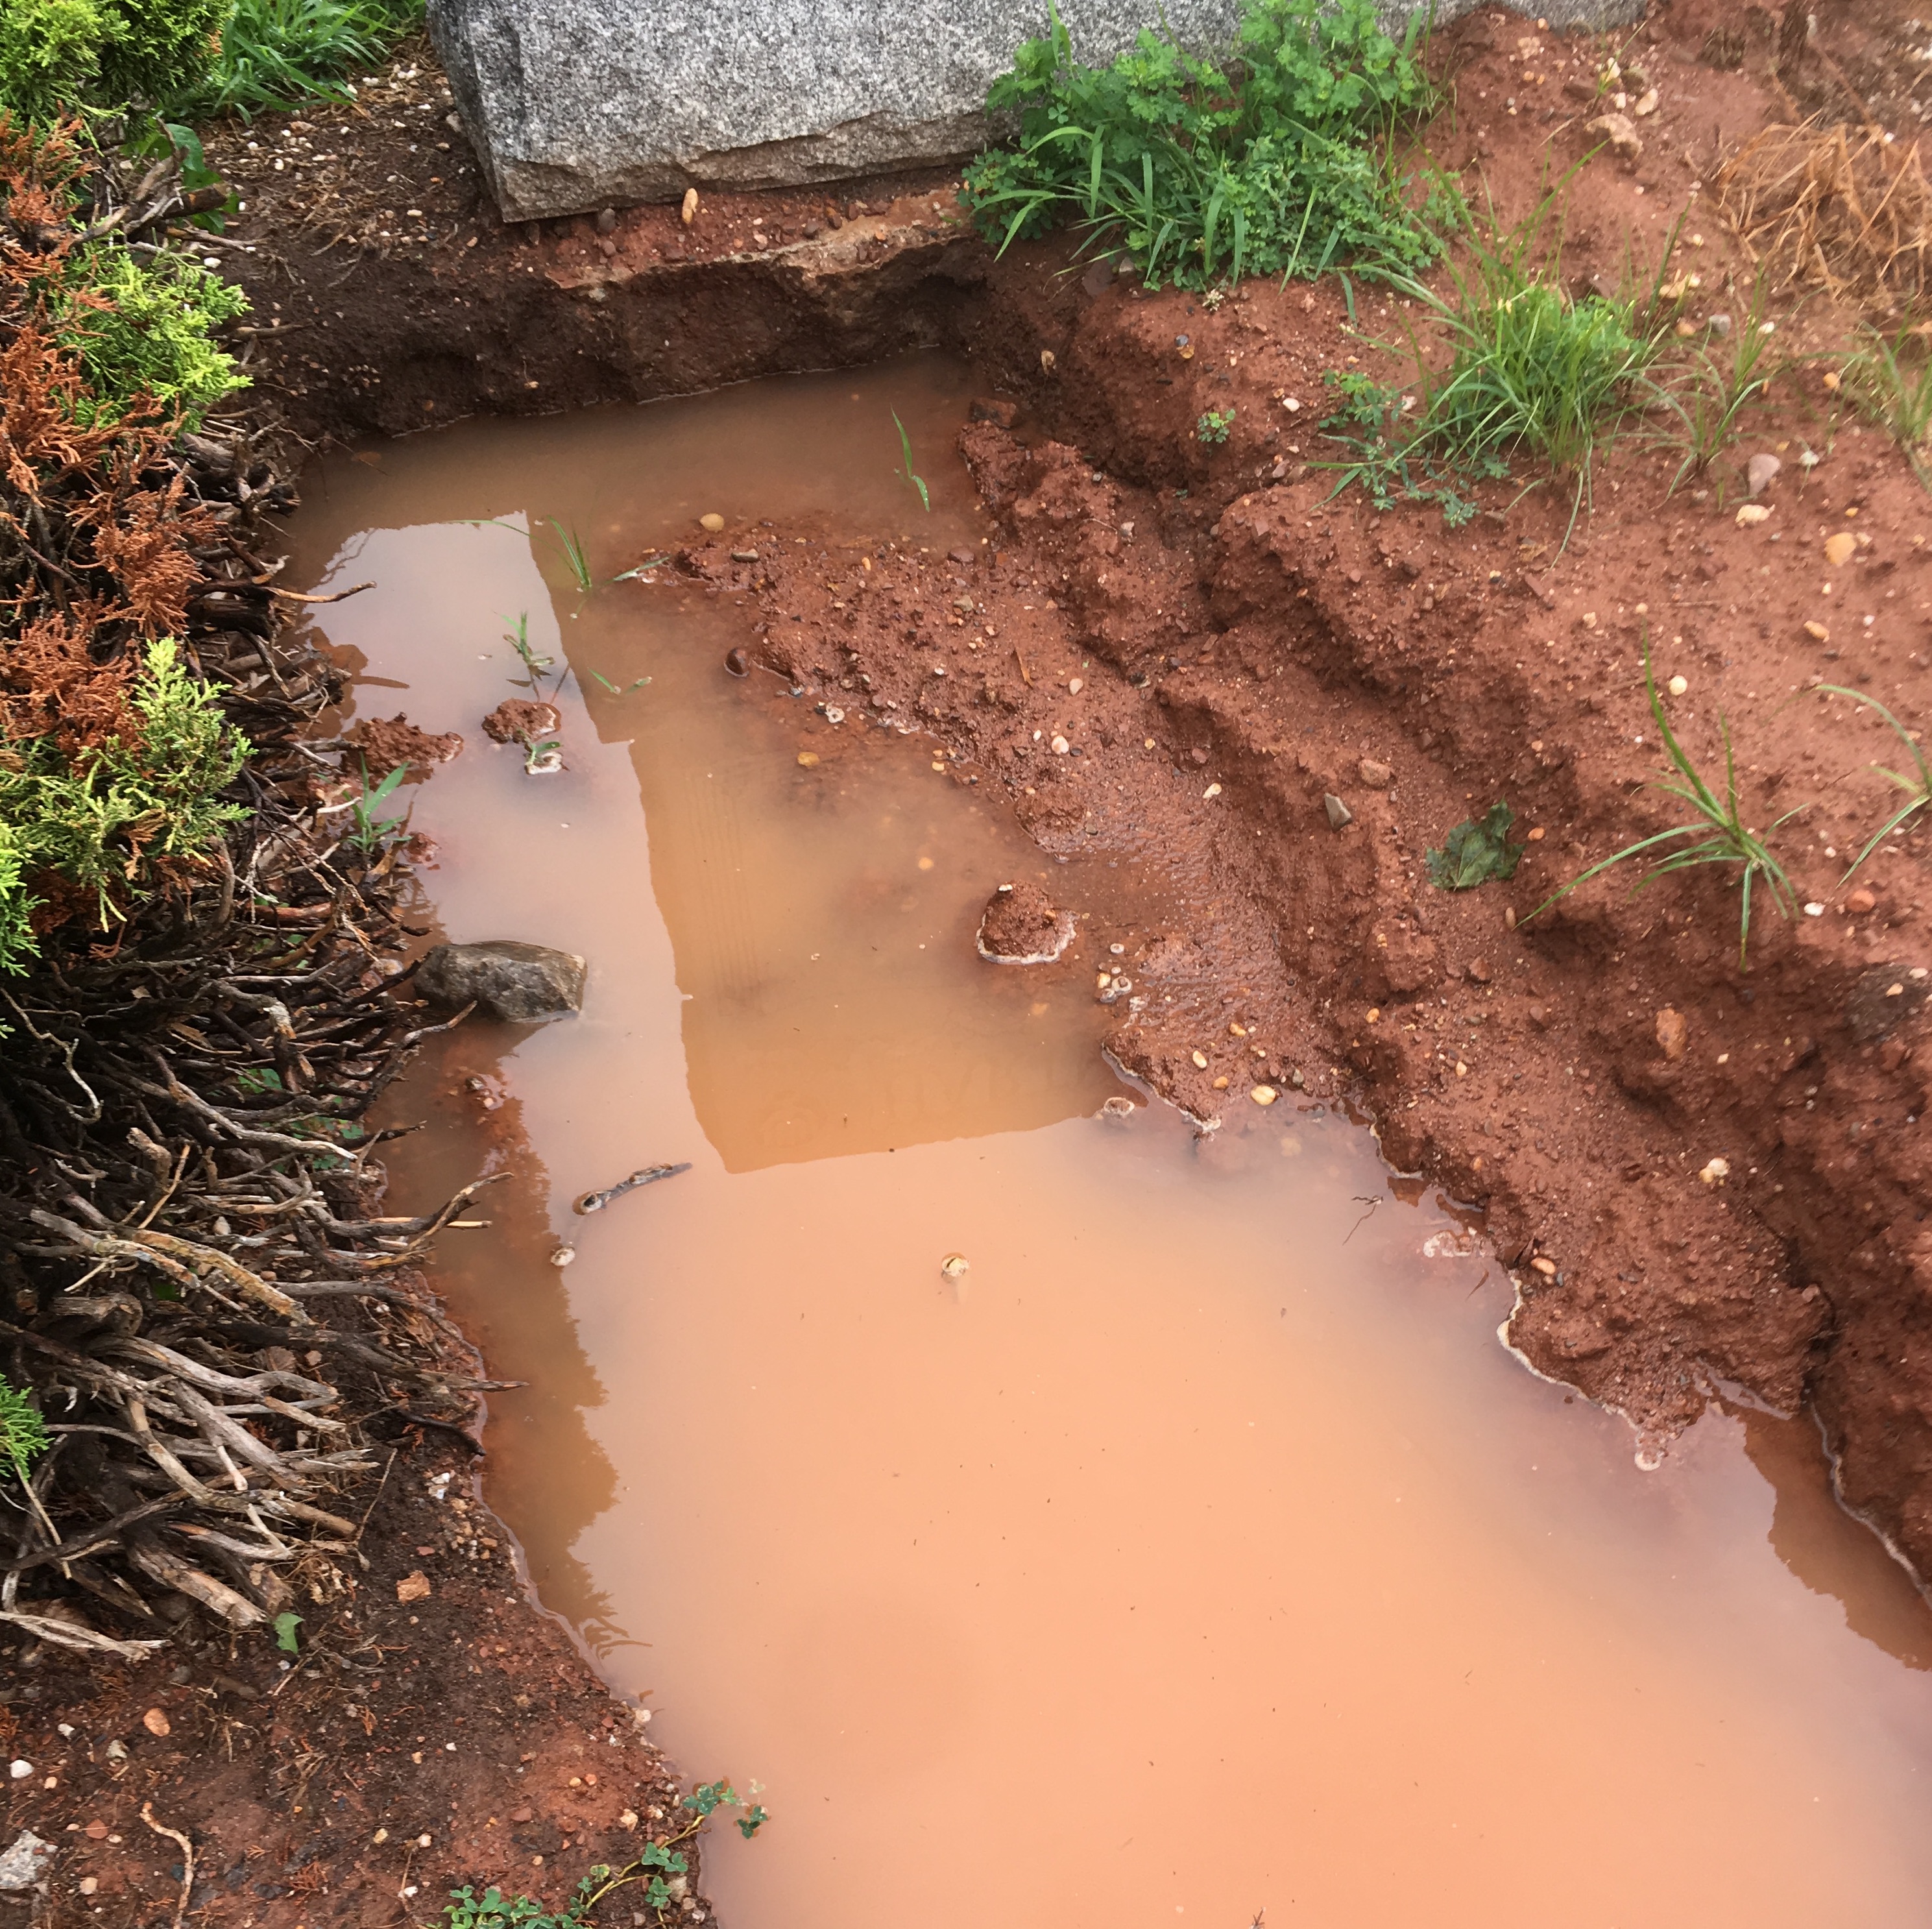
[168,0,423,120]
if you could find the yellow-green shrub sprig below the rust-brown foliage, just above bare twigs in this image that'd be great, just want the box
[0,636,249,972]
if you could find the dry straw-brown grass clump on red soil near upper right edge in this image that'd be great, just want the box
[1715,122,1932,321]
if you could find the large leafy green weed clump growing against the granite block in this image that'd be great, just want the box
[966,0,1436,288]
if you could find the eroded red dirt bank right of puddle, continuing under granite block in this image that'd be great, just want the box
[211,8,1932,1600]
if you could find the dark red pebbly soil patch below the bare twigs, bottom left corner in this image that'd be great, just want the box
[0,1432,707,1929]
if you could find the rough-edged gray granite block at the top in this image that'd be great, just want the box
[429,0,1642,221]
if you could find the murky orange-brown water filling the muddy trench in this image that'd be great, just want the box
[285,361,1932,1929]
